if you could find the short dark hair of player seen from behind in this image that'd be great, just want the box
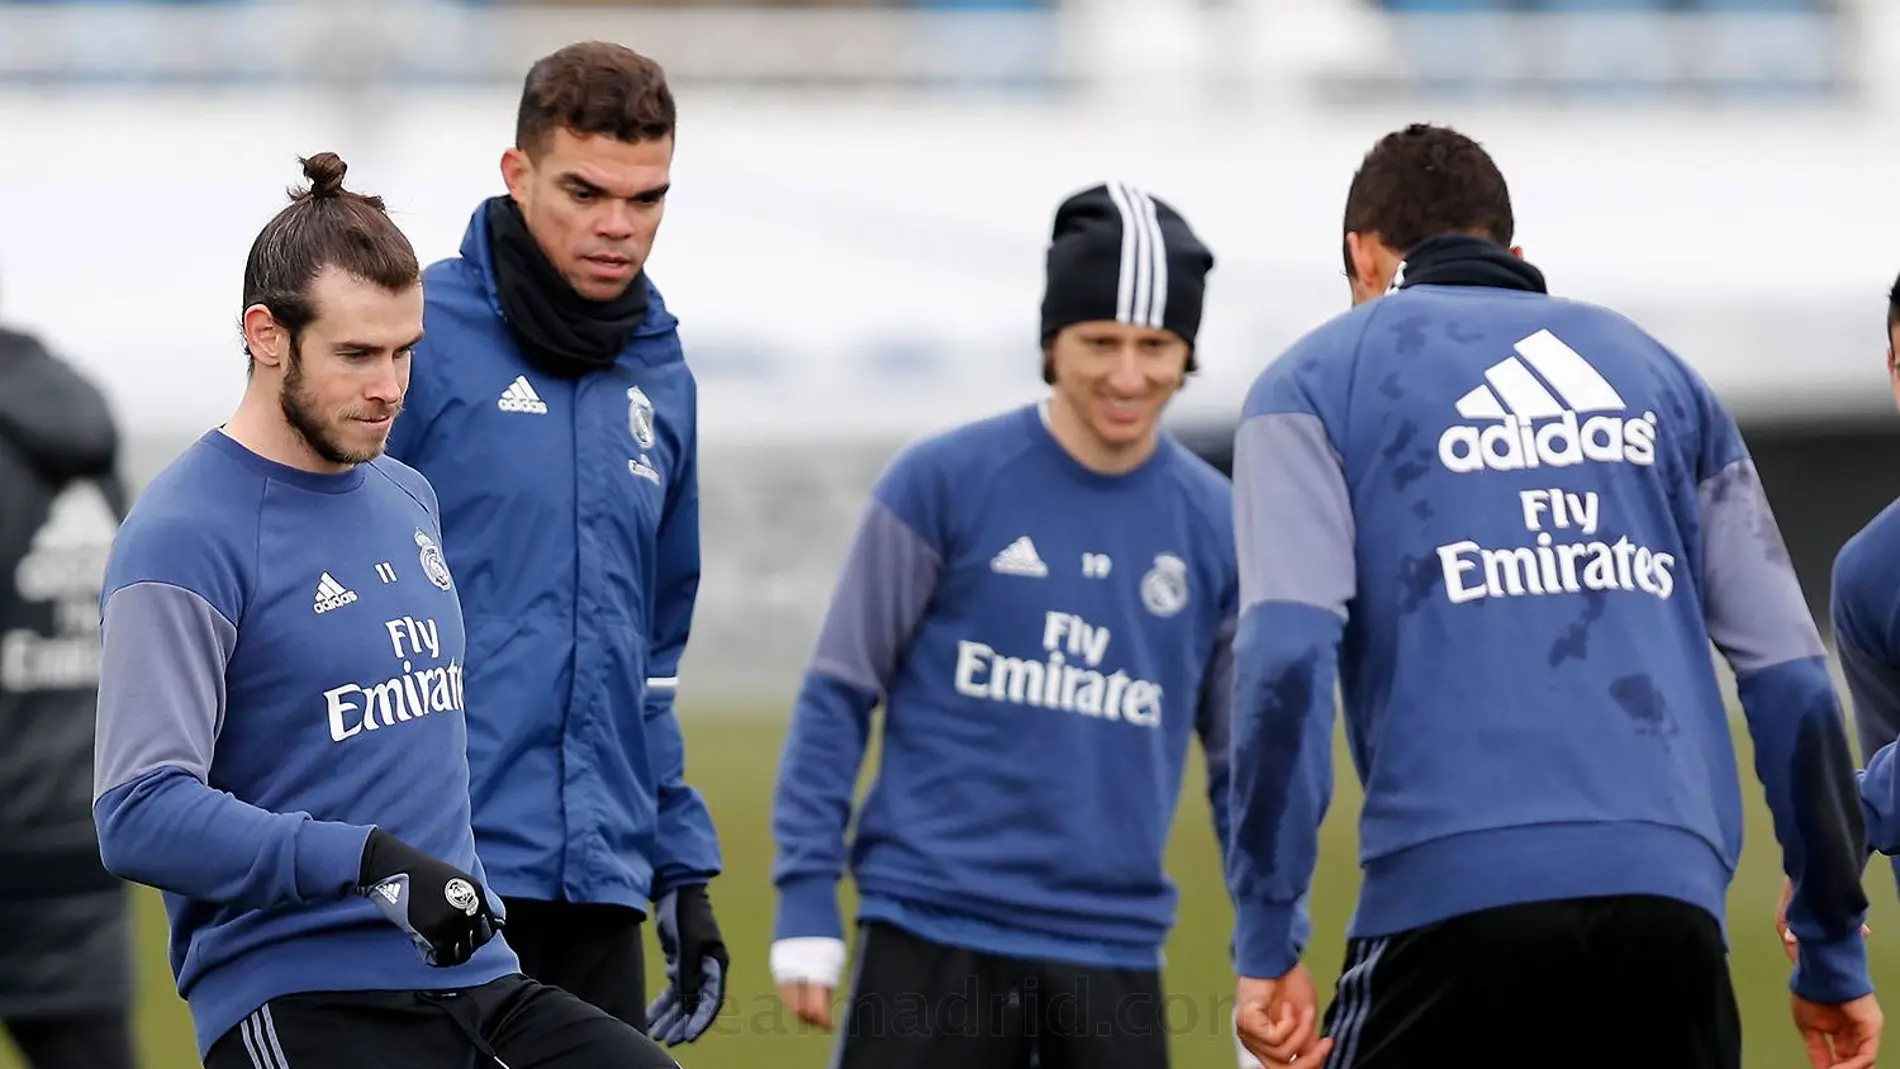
[1345,123,1514,277]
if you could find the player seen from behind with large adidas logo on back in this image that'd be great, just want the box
[1229,125,1879,1069]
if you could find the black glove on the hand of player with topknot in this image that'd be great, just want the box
[357,828,502,968]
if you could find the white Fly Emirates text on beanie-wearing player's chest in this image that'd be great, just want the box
[956,611,1161,727]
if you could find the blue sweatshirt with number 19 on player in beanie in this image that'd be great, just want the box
[771,406,1237,968]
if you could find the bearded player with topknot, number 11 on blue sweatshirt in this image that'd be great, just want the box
[95,152,676,1069]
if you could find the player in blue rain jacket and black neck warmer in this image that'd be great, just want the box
[390,42,730,1042]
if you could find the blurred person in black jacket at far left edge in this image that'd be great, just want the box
[0,320,137,1069]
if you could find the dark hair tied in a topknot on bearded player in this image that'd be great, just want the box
[243,152,422,364]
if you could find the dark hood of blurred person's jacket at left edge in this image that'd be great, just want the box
[0,328,118,482]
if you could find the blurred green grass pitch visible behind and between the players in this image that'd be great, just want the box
[0,706,1900,1069]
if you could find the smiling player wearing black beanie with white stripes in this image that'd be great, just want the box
[771,184,1239,1069]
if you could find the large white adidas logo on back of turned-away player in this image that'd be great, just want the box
[1438,330,1657,473]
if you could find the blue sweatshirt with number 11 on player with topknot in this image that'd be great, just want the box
[93,431,519,1056]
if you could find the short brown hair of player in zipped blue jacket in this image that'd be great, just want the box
[515,42,675,156]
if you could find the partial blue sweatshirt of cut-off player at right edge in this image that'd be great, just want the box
[1830,501,1900,883]
